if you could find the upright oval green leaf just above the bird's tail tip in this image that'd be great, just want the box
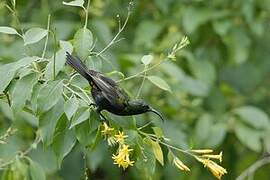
[74,28,93,60]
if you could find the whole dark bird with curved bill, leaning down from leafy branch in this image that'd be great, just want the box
[66,52,163,121]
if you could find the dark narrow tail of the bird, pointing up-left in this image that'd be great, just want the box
[66,52,92,81]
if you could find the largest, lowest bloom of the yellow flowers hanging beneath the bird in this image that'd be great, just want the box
[112,144,134,169]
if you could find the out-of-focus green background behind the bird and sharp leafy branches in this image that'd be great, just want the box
[0,0,270,180]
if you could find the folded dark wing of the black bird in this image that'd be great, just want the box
[92,73,129,107]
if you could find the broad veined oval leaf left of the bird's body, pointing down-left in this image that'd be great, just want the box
[38,80,63,112]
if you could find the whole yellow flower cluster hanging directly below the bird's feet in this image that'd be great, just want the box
[101,122,134,169]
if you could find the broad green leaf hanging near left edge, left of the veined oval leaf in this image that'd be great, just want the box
[11,73,38,111]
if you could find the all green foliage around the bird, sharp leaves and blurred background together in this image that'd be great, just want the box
[0,0,270,180]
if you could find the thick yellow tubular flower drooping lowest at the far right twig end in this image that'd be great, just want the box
[197,158,227,179]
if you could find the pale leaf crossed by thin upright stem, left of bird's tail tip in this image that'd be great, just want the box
[45,49,66,80]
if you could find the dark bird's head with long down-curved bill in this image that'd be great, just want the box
[129,99,164,121]
